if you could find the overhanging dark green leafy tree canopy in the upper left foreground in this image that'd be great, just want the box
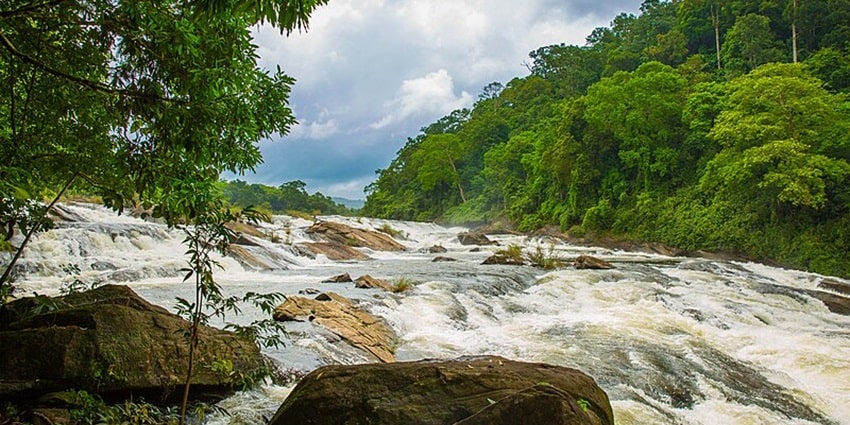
[0,0,327,292]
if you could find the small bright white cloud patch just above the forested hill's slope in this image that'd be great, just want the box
[370,69,473,129]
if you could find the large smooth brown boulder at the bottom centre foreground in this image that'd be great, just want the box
[269,356,614,425]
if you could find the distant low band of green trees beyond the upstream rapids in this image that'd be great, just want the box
[218,180,354,215]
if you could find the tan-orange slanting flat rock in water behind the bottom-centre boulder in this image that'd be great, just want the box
[272,292,395,363]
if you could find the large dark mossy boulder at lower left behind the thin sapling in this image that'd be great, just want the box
[0,285,264,399]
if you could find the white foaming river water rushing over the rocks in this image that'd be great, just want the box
[3,204,850,424]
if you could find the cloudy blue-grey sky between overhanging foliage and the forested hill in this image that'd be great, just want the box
[232,0,641,199]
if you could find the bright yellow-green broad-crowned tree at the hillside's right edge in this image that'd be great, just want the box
[701,64,850,221]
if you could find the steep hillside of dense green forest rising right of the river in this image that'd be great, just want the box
[363,0,850,276]
